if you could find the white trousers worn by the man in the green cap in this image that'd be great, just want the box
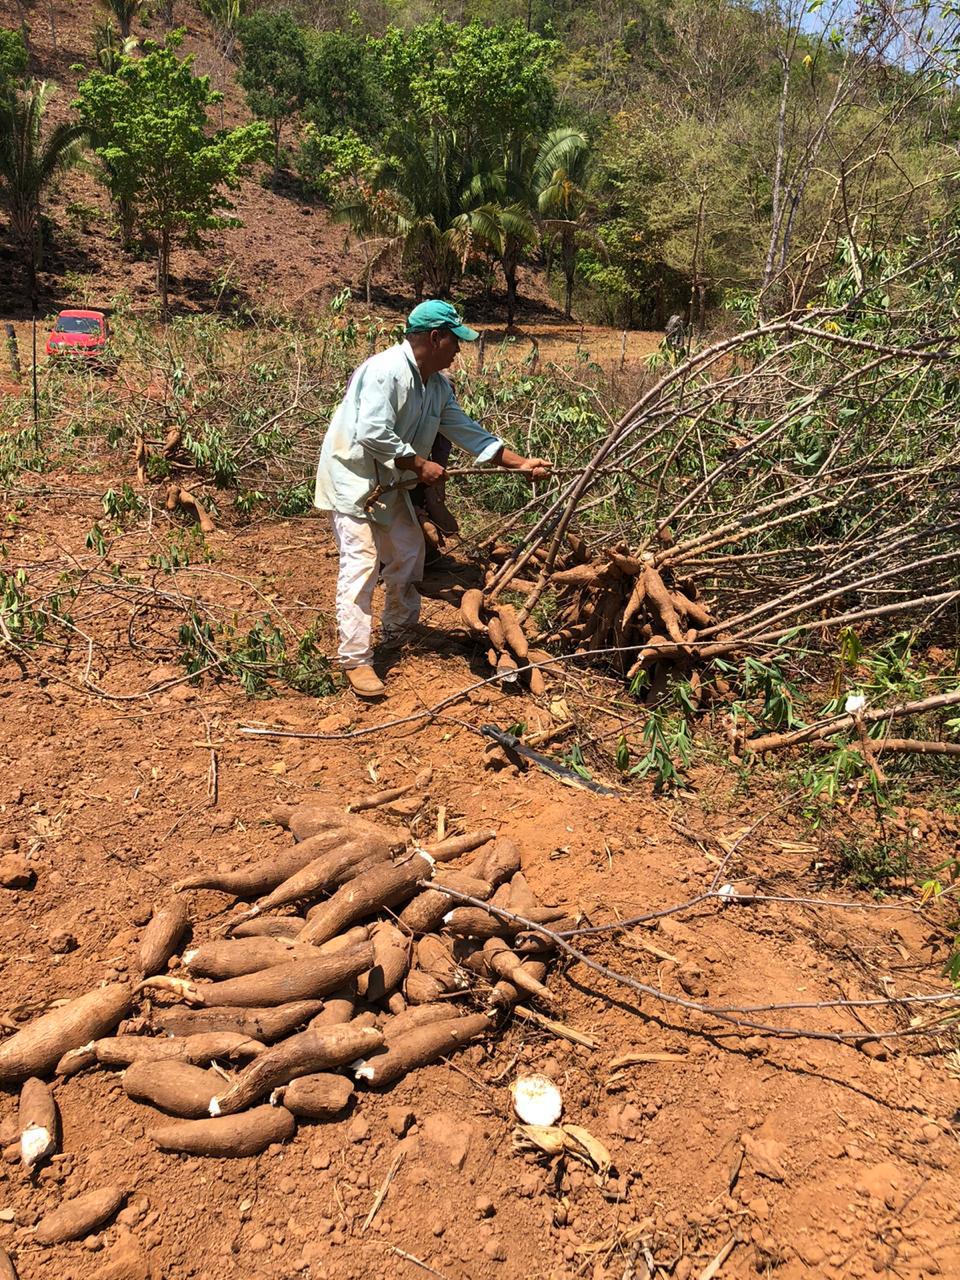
[333,503,424,669]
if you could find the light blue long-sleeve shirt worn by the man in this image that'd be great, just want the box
[314,342,503,524]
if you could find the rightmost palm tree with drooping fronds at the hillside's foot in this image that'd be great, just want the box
[532,127,605,320]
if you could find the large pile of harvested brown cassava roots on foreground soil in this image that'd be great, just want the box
[0,792,564,1243]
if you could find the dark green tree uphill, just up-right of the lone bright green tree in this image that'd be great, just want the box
[237,9,307,180]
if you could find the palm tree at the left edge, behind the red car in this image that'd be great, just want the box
[0,82,86,292]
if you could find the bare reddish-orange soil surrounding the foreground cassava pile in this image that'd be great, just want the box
[0,477,960,1280]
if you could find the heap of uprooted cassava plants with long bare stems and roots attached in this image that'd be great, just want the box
[466,298,960,747]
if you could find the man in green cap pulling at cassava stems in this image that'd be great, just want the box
[315,300,550,698]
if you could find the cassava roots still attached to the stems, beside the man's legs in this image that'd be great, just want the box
[476,531,713,694]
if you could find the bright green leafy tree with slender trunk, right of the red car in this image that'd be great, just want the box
[77,36,269,314]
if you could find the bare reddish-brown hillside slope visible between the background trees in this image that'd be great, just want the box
[0,0,570,321]
